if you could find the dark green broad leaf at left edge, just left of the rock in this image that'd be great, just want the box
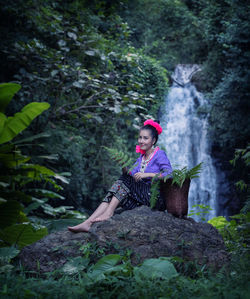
[0,223,48,249]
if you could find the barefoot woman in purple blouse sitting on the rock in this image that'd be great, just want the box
[68,119,172,232]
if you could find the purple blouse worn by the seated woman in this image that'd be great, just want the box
[130,149,172,180]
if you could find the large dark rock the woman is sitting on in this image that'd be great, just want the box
[20,206,229,272]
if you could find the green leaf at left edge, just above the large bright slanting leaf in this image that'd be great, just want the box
[0,83,21,113]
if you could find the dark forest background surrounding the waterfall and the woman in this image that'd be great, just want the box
[0,0,250,298]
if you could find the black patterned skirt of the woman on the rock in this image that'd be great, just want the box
[103,174,165,210]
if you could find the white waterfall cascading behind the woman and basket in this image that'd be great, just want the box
[160,65,217,220]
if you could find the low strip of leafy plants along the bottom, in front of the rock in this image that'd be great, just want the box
[0,255,250,299]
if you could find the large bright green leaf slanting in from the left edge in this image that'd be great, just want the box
[0,102,50,144]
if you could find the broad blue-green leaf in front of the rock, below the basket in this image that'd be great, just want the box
[134,257,178,280]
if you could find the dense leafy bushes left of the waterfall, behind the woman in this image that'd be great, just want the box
[0,0,168,209]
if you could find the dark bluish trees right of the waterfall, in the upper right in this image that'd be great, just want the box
[200,0,250,156]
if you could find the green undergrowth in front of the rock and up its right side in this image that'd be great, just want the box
[0,209,250,298]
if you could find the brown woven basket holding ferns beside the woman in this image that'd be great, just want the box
[161,179,190,218]
